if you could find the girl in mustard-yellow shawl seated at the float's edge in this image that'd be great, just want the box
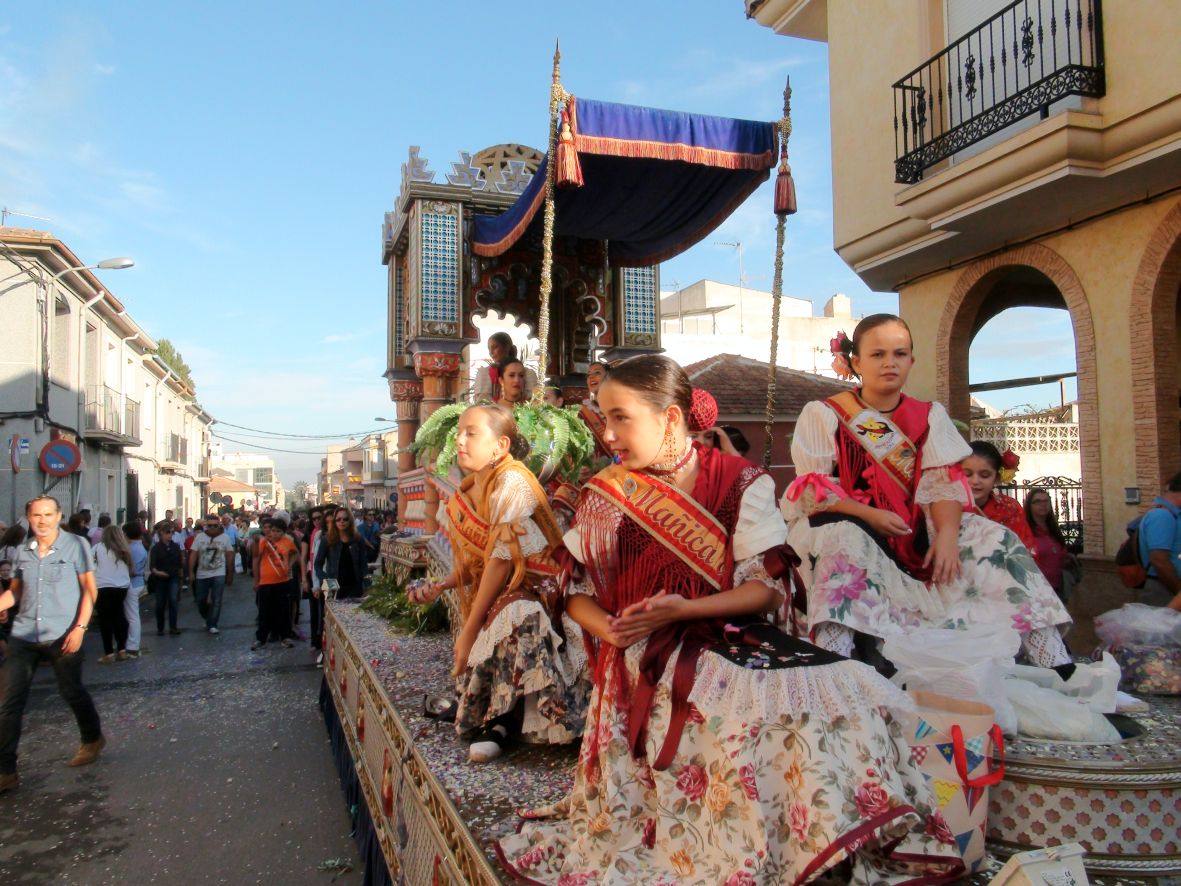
[411,405,589,763]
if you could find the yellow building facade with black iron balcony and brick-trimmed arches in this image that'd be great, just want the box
[746,0,1181,573]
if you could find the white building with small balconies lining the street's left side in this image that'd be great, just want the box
[0,227,213,521]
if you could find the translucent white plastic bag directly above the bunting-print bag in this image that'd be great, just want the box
[882,625,1022,735]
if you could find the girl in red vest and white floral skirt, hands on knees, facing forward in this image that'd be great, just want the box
[783,314,1075,679]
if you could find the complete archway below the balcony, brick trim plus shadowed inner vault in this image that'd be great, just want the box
[935,245,1104,556]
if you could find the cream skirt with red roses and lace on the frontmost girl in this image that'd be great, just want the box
[497,643,963,886]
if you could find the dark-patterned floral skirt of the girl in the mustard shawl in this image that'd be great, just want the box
[455,599,591,744]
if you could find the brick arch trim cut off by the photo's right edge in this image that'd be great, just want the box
[1129,202,1181,503]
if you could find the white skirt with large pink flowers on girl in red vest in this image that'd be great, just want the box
[788,514,1070,638]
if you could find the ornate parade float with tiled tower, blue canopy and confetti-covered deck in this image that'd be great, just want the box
[321,46,1181,885]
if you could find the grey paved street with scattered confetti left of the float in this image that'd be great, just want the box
[0,576,361,886]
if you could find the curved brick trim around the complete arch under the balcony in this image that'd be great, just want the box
[935,243,1104,556]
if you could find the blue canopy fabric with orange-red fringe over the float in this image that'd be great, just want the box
[471,98,776,267]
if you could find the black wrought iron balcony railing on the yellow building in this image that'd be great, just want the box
[894,0,1107,184]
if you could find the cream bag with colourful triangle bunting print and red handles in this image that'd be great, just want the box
[902,691,1005,872]
